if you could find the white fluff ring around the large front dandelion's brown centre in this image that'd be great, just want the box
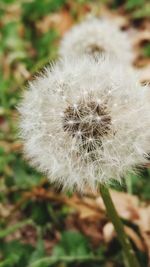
[19,56,150,191]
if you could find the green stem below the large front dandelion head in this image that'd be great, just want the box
[100,185,140,267]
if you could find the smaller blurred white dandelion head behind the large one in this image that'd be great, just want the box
[60,18,133,63]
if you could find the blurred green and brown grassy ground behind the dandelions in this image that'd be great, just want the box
[0,0,150,267]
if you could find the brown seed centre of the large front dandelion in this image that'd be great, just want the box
[63,101,111,141]
